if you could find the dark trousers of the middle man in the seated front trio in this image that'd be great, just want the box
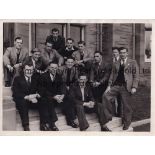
[39,97,58,125]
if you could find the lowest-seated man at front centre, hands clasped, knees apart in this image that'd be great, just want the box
[69,73,108,131]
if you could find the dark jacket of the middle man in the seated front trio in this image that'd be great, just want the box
[39,72,63,99]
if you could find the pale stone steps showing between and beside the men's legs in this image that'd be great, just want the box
[3,87,133,132]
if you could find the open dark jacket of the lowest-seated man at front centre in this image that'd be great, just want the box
[69,83,94,104]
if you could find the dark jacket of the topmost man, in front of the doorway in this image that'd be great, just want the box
[46,35,65,54]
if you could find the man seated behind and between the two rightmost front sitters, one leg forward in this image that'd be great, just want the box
[59,57,78,128]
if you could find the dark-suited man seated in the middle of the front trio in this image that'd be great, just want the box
[39,62,64,131]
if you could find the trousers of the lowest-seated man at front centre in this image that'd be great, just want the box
[76,102,104,130]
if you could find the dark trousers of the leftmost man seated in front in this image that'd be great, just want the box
[15,99,38,127]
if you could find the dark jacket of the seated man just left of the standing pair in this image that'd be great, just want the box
[90,61,111,84]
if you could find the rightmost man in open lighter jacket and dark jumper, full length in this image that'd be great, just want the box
[102,47,139,130]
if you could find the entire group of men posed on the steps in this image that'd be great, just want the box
[3,28,139,131]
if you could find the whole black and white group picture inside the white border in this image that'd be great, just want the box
[1,20,152,135]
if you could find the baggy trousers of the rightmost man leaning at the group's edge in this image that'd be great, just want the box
[102,85,133,124]
